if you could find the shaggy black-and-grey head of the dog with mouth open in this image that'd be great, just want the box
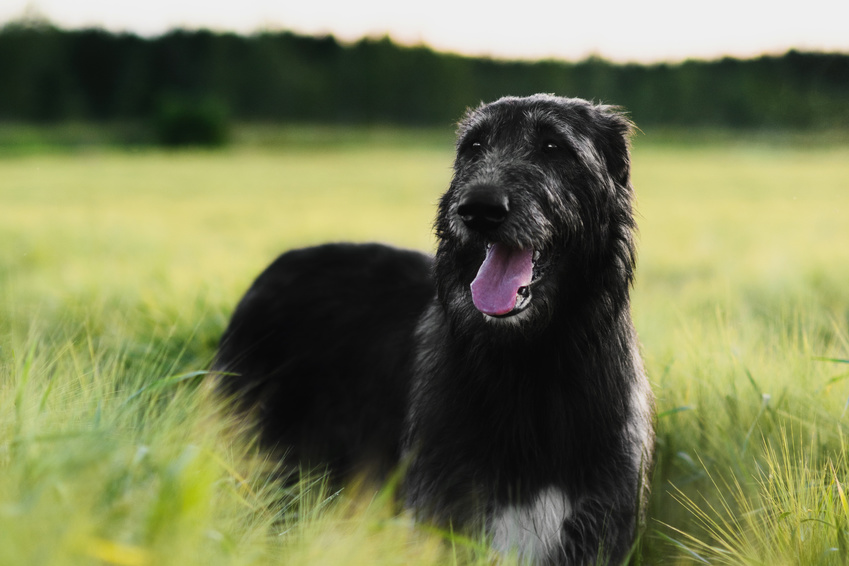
[436,95,634,332]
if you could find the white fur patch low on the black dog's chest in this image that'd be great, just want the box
[489,487,572,564]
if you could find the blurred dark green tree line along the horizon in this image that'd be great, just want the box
[0,22,849,129]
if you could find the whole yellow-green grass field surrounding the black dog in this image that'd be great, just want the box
[0,131,849,566]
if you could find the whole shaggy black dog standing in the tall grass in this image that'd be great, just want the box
[216,95,654,564]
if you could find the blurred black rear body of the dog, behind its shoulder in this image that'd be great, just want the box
[214,244,434,482]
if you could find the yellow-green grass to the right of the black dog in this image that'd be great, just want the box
[634,140,849,564]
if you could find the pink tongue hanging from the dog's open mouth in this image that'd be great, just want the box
[471,244,534,315]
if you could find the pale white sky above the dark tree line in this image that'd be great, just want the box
[0,0,849,63]
